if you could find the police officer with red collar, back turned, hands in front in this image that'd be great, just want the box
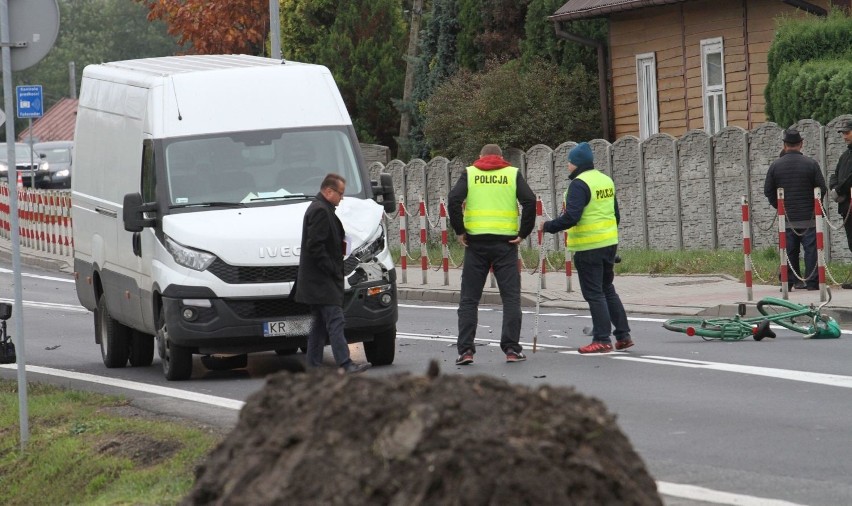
[447,144,535,365]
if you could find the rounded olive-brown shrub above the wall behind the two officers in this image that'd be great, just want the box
[424,60,601,160]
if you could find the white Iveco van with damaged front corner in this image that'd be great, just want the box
[71,55,397,380]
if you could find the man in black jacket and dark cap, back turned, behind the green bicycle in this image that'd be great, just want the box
[763,128,828,290]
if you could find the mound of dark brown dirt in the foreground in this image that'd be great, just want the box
[184,362,662,506]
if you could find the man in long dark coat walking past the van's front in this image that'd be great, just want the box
[295,174,370,373]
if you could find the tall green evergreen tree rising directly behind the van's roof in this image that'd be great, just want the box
[281,0,407,146]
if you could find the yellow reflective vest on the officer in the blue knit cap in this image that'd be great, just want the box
[565,169,618,251]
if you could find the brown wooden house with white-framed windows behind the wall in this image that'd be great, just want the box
[550,0,836,139]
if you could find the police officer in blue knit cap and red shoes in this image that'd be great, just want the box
[544,142,633,354]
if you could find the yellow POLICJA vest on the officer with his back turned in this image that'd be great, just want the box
[464,166,518,236]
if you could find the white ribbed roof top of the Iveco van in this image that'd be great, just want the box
[102,54,309,76]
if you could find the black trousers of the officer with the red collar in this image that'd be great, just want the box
[458,241,522,355]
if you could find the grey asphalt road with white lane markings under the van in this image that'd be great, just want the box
[0,263,852,505]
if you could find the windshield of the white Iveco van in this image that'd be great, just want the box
[163,127,362,206]
